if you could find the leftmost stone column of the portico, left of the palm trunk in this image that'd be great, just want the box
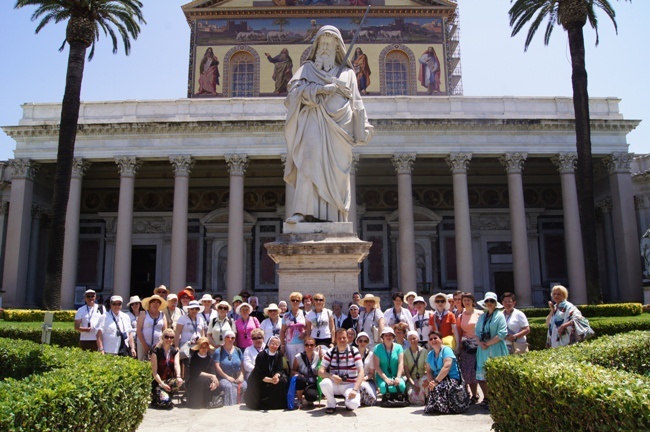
[2,159,39,308]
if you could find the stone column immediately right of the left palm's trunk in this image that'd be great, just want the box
[61,158,90,309]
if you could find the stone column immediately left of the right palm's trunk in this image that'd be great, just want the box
[551,152,587,304]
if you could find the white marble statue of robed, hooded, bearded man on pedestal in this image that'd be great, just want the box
[284,26,373,223]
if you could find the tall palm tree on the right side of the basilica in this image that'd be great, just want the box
[508,0,627,304]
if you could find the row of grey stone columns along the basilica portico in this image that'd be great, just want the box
[2,152,641,308]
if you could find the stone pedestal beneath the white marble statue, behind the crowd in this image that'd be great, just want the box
[264,222,371,307]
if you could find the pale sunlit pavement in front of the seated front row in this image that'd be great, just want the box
[138,401,492,432]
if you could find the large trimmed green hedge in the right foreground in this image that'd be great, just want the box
[486,332,650,431]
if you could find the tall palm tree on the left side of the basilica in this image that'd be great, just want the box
[15,0,145,309]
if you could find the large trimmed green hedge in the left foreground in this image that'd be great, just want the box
[0,339,151,431]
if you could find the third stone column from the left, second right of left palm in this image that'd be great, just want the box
[113,156,142,299]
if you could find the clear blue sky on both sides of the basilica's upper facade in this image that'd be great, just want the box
[0,0,650,160]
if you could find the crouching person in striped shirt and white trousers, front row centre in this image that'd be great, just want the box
[318,329,364,414]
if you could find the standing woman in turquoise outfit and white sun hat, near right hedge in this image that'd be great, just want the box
[476,291,508,408]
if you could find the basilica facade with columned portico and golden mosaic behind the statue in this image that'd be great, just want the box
[0,0,650,308]
